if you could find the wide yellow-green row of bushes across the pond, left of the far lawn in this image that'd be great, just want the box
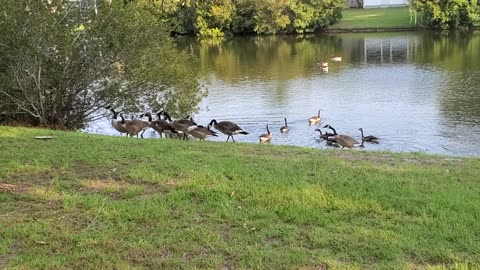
[142,0,346,37]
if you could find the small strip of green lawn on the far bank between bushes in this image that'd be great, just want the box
[329,7,416,30]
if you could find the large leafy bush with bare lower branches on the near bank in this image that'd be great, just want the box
[0,0,203,129]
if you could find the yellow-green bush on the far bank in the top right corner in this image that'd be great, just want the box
[410,0,480,29]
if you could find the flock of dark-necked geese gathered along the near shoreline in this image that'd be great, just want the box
[106,106,379,148]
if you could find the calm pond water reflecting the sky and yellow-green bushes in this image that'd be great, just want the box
[90,32,480,156]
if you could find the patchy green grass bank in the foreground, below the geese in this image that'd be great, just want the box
[0,127,480,269]
